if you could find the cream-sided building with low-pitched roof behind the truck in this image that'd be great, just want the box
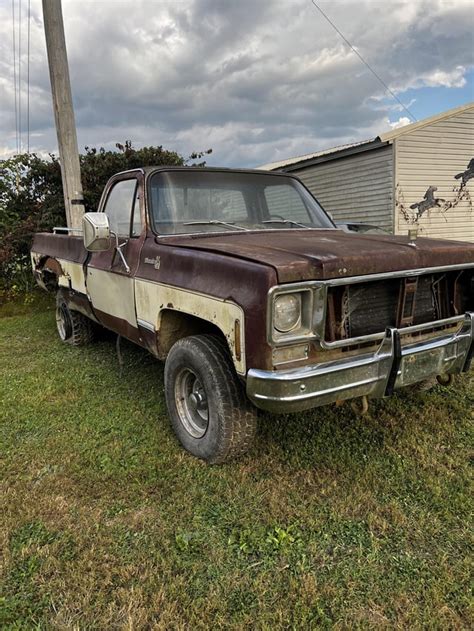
[260,103,474,241]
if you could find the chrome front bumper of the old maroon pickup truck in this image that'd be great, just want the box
[247,313,474,413]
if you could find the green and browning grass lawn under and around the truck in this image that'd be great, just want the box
[0,301,474,629]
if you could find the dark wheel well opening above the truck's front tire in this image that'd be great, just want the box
[157,309,229,359]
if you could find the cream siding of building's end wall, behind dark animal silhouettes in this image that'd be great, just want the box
[394,107,474,241]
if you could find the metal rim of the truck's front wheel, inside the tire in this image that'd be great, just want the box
[175,368,209,438]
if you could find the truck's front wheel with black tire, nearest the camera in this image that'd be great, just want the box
[165,335,257,464]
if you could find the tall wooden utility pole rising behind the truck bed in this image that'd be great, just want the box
[43,0,84,228]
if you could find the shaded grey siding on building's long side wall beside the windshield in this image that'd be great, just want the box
[293,145,393,231]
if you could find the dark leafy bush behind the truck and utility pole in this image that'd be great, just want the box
[0,141,211,295]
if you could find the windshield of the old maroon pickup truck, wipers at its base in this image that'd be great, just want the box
[150,169,334,234]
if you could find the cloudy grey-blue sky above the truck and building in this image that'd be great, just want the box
[0,0,474,167]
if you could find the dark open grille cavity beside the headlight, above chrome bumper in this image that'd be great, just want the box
[326,270,474,341]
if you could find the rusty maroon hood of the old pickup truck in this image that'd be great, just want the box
[160,229,474,283]
